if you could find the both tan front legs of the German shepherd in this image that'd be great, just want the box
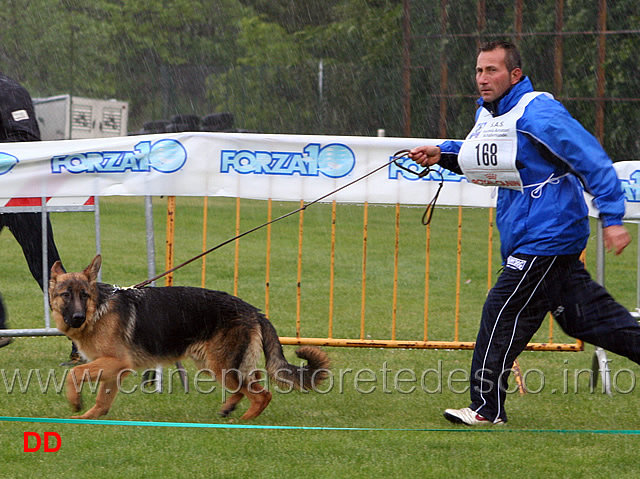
[67,358,129,419]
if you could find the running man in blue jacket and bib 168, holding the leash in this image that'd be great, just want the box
[410,42,640,426]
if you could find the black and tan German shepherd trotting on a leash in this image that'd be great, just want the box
[49,255,329,419]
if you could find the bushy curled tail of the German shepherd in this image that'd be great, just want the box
[260,315,330,390]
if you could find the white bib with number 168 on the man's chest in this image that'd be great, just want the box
[458,92,550,192]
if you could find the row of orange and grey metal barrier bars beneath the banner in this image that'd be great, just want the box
[5,197,640,366]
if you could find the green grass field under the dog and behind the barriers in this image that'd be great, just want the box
[0,198,640,478]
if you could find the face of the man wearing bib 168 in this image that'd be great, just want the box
[476,48,522,102]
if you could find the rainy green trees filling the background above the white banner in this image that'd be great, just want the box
[0,0,640,152]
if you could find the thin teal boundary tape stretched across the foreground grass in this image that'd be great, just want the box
[0,416,640,436]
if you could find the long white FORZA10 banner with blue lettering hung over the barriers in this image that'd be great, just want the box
[0,133,640,220]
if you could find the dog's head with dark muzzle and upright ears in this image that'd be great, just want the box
[49,255,102,334]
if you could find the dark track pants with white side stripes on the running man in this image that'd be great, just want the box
[470,254,640,421]
